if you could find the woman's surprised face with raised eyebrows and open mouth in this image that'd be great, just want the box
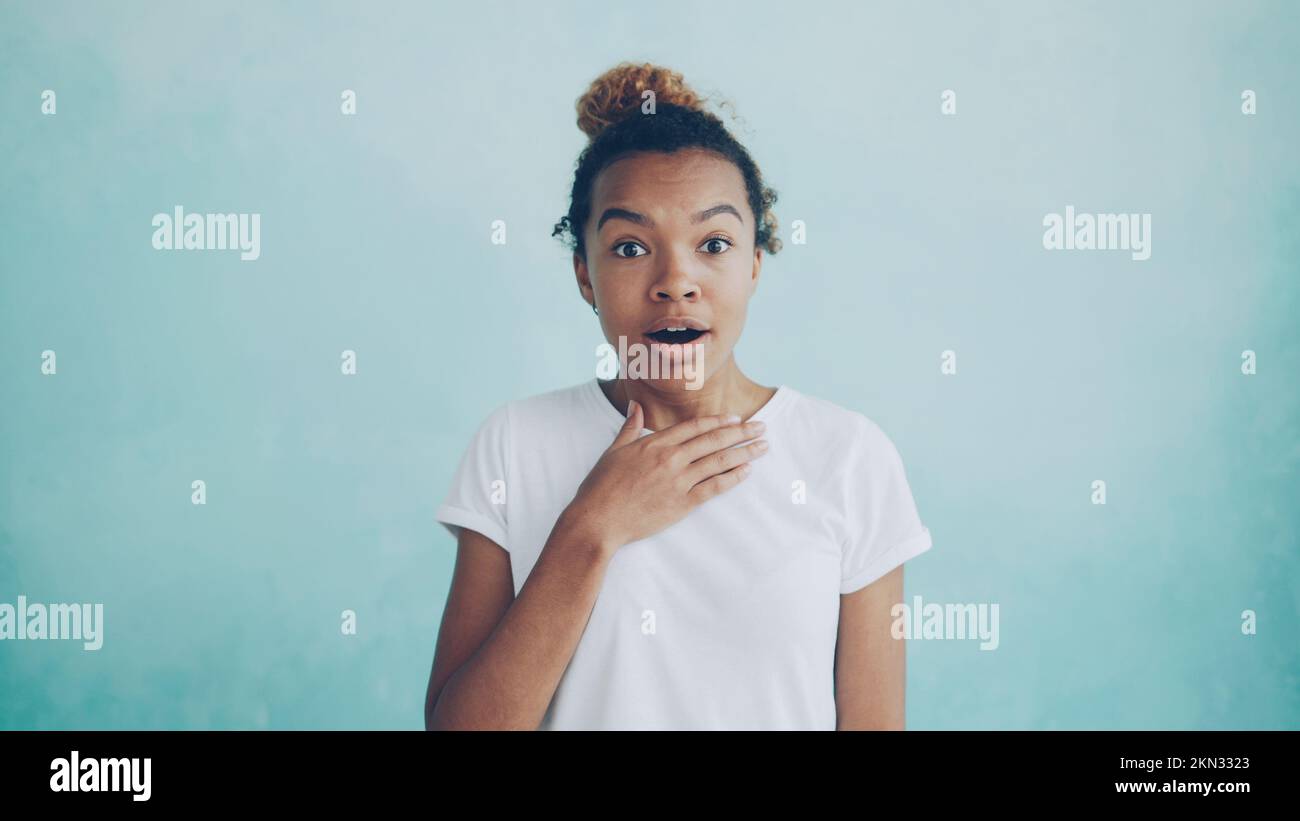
[573,149,762,391]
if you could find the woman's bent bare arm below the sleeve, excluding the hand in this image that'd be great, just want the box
[424,517,615,730]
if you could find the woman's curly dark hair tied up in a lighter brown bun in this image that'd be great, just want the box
[551,62,781,260]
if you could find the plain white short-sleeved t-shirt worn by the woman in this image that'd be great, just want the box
[436,378,931,730]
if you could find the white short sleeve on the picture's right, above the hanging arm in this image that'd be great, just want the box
[840,417,931,594]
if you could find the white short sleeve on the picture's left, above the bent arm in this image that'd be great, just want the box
[434,404,510,551]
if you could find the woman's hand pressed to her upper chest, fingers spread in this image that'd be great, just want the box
[560,401,767,552]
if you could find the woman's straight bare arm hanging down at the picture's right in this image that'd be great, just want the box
[835,565,907,730]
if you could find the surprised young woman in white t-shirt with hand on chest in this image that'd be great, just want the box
[425,64,931,730]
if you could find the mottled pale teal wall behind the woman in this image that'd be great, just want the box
[0,1,1300,729]
